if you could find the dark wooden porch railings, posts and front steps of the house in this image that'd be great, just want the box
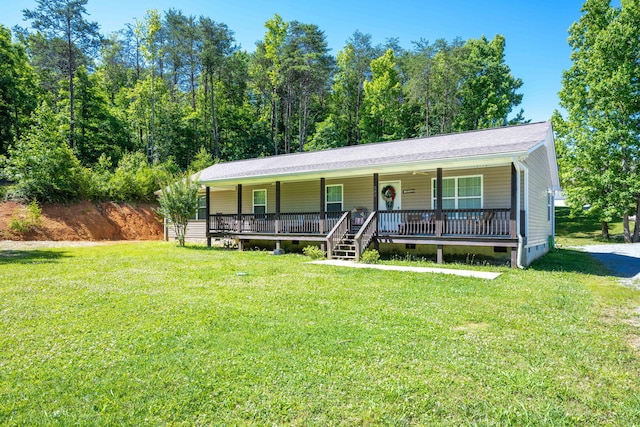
[206,166,525,266]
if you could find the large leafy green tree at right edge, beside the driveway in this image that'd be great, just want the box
[554,0,640,241]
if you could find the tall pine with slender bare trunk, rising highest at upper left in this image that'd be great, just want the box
[23,0,100,148]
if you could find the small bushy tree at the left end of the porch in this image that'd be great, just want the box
[158,176,198,246]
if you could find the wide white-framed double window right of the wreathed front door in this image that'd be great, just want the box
[431,175,482,209]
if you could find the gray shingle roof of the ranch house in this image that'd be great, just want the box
[199,122,551,183]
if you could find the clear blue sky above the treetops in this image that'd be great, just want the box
[0,0,583,122]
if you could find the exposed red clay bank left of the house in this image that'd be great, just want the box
[0,201,163,241]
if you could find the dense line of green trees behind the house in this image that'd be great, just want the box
[0,0,525,204]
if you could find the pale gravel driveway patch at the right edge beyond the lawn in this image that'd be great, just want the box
[582,243,640,289]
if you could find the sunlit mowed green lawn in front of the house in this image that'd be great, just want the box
[0,243,640,426]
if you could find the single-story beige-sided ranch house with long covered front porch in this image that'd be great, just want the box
[166,122,560,266]
